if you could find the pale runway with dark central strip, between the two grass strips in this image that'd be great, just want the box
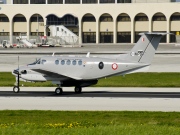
[0,87,180,112]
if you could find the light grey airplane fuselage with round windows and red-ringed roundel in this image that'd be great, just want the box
[11,56,149,81]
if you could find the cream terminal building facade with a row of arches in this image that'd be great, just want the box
[0,0,180,44]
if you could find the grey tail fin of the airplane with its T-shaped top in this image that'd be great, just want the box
[125,33,169,63]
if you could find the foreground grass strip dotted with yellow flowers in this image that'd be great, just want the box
[0,110,180,135]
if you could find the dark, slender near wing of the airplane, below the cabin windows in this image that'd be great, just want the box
[31,69,82,80]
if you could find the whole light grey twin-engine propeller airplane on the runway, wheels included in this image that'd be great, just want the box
[12,33,167,94]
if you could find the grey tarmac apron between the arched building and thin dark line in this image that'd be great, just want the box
[0,44,180,55]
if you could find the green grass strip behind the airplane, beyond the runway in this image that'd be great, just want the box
[0,72,180,87]
